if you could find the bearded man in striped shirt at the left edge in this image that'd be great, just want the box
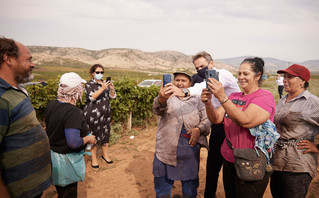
[0,37,51,198]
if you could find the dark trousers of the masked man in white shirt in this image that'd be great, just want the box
[204,124,225,198]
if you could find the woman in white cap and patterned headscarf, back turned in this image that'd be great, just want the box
[45,72,96,198]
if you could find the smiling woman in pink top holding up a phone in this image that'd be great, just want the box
[201,57,276,198]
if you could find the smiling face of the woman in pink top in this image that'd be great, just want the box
[238,62,260,92]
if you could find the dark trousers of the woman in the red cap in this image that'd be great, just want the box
[270,171,312,198]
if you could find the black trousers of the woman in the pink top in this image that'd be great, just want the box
[223,160,270,198]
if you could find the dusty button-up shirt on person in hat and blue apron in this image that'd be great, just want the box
[153,96,211,166]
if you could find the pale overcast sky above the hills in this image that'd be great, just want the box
[0,0,319,62]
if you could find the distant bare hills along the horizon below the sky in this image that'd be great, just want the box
[28,46,319,73]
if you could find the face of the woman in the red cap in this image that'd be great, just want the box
[284,73,306,94]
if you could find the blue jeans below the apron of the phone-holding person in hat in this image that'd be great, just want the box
[154,176,199,198]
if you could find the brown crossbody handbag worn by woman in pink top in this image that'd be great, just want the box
[226,139,267,181]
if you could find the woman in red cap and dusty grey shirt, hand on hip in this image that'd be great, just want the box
[270,64,319,198]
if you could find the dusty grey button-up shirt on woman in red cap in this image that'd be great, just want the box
[272,90,319,177]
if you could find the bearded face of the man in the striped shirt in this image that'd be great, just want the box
[10,43,35,84]
